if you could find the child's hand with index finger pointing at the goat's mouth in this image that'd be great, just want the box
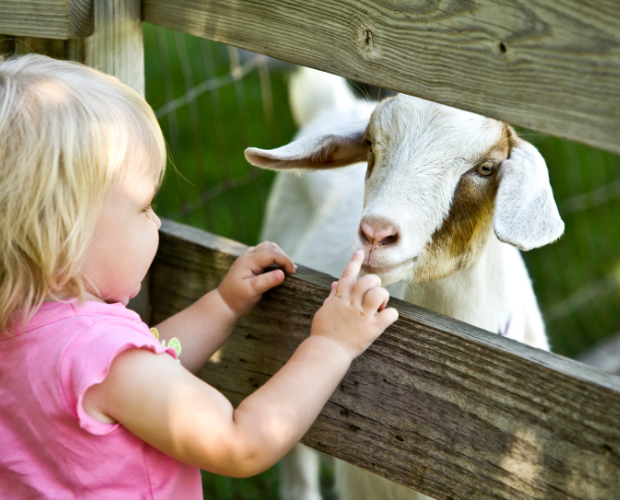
[310,250,398,359]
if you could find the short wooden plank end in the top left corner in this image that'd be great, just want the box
[0,0,94,40]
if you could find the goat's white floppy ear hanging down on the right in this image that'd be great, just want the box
[493,138,564,250]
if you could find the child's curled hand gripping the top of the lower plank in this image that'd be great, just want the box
[218,241,297,316]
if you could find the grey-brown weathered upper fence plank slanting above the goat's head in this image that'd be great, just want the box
[144,0,620,152]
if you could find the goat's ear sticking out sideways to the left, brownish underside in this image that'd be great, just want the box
[245,120,368,170]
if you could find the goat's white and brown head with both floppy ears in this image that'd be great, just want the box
[246,95,564,285]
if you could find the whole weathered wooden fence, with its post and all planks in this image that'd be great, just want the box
[0,0,620,500]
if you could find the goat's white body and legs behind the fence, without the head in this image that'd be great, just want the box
[262,68,548,500]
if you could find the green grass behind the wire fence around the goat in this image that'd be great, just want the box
[144,24,620,500]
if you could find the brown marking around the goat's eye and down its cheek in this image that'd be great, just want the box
[414,124,516,281]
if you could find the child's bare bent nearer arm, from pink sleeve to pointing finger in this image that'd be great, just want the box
[84,252,398,477]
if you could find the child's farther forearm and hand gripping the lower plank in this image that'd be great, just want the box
[151,242,295,372]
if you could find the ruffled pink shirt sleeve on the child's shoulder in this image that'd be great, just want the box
[60,318,177,435]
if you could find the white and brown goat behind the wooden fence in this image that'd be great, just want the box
[246,69,564,500]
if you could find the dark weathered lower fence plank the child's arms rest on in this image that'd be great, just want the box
[151,221,620,500]
